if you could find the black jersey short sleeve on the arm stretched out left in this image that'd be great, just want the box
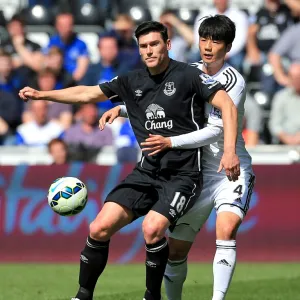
[99,76,129,103]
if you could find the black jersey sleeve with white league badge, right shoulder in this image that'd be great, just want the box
[190,67,224,102]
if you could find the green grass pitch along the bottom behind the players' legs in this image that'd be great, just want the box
[0,263,300,300]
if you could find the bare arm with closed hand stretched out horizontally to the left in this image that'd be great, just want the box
[19,85,108,104]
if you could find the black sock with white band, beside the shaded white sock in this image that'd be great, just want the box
[144,237,169,300]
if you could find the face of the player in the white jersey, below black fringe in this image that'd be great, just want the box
[199,37,231,65]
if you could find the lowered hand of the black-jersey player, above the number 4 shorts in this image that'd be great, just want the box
[218,153,240,181]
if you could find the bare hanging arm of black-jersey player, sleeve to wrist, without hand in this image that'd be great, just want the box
[210,90,238,153]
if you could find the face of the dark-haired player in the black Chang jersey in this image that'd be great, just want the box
[139,32,171,69]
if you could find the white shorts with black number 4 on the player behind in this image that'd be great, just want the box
[169,173,255,242]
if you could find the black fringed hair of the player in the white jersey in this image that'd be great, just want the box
[198,15,235,45]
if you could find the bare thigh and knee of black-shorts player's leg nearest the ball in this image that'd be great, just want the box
[90,202,134,240]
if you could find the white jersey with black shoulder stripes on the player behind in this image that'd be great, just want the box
[191,61,252,177]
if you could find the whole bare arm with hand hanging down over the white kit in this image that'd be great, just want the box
[210,90,240,181]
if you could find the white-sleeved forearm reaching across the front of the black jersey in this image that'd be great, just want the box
[170,124,223,149]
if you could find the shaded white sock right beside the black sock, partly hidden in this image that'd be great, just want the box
[164,257,187,300]
